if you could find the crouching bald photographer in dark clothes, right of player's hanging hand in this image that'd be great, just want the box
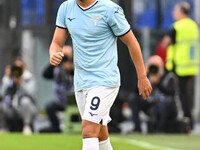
[132,55,177,132]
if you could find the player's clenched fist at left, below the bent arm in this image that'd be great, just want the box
[50,52,64,66]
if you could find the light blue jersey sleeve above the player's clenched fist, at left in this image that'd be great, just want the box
[56,2,67,28]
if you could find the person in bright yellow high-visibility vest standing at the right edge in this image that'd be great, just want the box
[163,2,199,128]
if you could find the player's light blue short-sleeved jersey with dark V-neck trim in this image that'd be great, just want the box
[56,0,130,91]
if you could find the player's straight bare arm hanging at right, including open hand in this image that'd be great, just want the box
[120,30,152,99]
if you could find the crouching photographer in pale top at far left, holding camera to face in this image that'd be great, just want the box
[1,59,37,135]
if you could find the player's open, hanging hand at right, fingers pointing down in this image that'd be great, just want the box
[138,77,152,100]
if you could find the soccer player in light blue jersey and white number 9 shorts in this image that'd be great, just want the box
[49,0,152,150]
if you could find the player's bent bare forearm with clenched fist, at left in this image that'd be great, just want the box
[49,27,68,66]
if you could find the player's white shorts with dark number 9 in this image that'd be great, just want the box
[75,86,119,126]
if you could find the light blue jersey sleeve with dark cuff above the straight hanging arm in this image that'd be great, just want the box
[108,6,130,36]
